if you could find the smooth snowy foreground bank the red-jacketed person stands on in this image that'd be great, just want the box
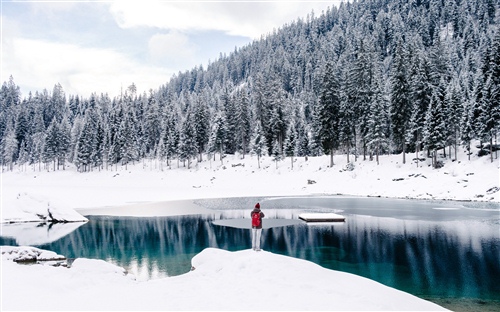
[2,246,444,311]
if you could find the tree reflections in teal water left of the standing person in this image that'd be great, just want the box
[41,216,250,275]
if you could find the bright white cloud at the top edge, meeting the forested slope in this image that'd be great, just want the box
[110,0,339,39]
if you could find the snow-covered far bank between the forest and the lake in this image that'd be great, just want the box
[1,145,500,222]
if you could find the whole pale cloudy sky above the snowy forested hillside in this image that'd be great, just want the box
[1,0,340,97]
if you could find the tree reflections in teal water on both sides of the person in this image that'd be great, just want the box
[41,212,500,299]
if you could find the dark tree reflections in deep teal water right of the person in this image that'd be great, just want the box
[264,216,500,300]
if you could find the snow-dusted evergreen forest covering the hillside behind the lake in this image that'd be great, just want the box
[0,0,500,171]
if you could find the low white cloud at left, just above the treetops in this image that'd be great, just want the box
[2,38,174,96]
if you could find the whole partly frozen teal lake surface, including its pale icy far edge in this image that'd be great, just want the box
[0,197,500,311]
